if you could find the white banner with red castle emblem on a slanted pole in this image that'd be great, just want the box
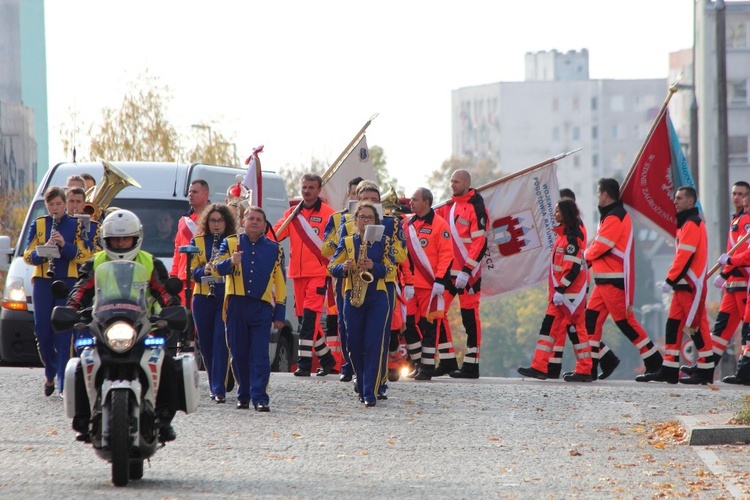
[481,163,560,296]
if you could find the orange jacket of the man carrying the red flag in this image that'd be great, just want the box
[585,201,633,290]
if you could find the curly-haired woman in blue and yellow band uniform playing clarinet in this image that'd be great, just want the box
[190,203,236,403]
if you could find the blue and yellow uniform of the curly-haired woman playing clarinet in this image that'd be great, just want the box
[190,234,229,398]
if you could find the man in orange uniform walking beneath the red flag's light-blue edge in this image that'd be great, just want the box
[635,186,714,385]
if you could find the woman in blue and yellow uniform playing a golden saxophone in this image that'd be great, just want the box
[328,202,394,407]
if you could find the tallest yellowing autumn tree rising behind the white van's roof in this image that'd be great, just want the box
[90,73,180,162]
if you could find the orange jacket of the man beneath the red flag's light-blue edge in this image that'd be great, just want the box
[664,207,708,292]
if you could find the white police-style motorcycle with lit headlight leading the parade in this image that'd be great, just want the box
[52,261,199,486]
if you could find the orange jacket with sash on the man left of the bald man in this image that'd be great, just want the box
[404,209,453,289]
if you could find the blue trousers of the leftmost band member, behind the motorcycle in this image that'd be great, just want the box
[31,278,76,392]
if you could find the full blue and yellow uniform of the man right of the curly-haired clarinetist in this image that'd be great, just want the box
[219,233,286,407]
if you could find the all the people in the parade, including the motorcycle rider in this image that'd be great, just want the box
[24,170,750,426]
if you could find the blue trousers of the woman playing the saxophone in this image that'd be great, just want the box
[344,286,391,402]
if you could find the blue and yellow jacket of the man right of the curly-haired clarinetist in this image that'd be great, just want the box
[214,233,286,321]
